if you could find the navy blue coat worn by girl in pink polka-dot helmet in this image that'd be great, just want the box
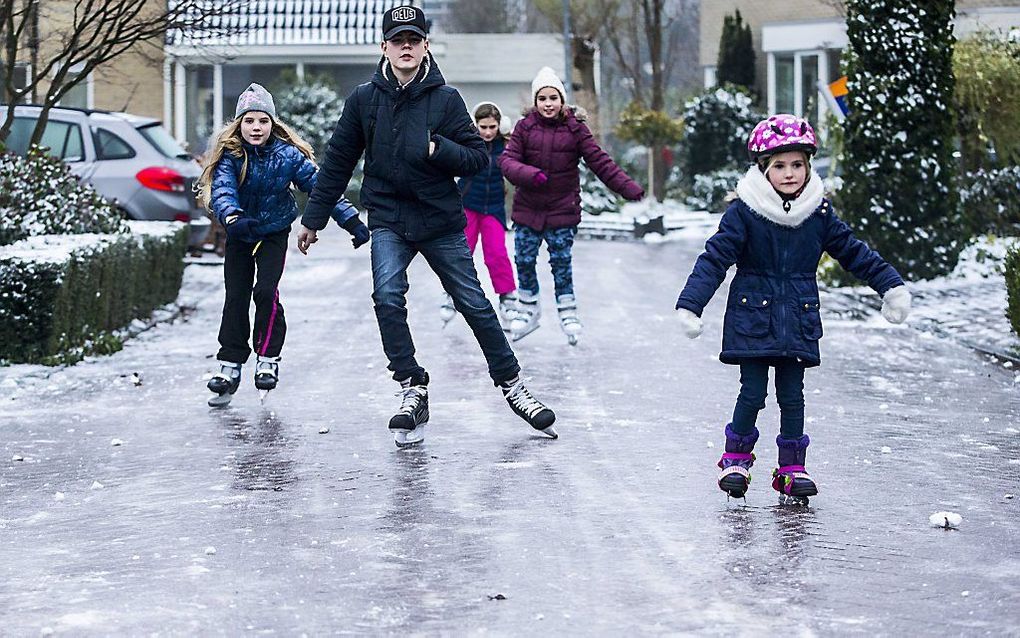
[676,170,903,367]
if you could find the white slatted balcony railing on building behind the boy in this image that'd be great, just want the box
[166,0,421,46]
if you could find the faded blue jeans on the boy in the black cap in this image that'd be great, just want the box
[371,228,520,384]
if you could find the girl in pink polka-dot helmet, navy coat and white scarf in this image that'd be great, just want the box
[676,114,910,503]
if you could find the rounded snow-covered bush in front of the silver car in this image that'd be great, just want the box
[0,148,128,246]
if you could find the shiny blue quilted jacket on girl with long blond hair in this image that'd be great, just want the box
[211,137,358,237]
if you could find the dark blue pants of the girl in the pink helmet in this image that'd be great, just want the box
[733,359,804,439]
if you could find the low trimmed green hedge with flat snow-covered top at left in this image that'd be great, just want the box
[0,222,188,364]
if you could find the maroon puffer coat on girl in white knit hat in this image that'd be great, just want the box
[500,108,645,231]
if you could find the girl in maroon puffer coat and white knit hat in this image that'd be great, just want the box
[500,66,645,345]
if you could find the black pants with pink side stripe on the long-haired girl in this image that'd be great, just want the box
[216,229,291,363]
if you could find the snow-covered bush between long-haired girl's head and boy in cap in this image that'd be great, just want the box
[276,80,344,161]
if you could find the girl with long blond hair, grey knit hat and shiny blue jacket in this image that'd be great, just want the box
[197,84,369,405]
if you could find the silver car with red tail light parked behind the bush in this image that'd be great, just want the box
[0,105,210,248]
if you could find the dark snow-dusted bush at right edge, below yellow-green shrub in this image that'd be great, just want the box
[960,166,1020,235]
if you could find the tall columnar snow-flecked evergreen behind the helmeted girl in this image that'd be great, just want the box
[839,0,954,279]
